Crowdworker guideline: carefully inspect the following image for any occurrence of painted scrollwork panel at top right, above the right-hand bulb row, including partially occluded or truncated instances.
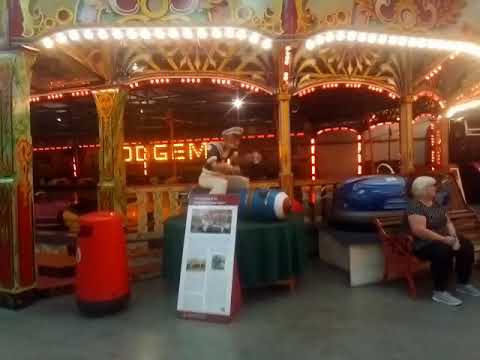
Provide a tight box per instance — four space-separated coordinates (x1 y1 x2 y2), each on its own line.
296 0 480 37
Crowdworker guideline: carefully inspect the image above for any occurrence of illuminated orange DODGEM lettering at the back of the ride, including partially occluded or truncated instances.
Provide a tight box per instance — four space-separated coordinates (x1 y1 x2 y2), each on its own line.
123 142 208 163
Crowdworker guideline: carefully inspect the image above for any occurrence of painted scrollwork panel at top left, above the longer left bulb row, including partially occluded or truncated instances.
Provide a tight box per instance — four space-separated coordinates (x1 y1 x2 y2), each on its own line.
12 0 282 38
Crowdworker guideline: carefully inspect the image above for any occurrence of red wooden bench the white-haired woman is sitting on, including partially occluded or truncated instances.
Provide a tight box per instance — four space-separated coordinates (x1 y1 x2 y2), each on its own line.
375 208 480 297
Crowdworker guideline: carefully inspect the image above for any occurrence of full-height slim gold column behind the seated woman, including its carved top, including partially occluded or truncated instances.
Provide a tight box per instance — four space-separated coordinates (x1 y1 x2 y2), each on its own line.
400 52 415 176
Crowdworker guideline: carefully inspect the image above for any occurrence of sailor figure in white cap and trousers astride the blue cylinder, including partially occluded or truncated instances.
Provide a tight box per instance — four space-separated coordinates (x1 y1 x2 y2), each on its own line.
198 127 249 195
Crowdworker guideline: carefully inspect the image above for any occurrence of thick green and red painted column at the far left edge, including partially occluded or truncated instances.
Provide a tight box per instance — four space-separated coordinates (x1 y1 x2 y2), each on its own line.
0 50 36 308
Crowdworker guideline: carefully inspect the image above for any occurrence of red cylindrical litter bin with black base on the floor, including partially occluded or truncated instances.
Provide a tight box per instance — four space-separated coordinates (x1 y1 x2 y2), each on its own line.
75 212 130 315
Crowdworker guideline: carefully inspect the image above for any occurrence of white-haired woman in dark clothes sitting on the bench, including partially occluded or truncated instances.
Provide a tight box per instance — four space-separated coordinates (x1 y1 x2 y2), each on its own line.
407 176 480 306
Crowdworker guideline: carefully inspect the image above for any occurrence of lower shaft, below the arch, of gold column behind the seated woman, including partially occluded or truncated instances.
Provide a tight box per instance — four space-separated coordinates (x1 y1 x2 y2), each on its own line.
400 95 415 175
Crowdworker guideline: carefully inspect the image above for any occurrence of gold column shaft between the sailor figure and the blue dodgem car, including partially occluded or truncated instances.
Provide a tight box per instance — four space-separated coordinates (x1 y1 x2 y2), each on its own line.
277 92 293 196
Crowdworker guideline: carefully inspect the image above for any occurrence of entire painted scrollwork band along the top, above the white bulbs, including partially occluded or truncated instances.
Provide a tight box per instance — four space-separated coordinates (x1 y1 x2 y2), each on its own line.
6 0 480 39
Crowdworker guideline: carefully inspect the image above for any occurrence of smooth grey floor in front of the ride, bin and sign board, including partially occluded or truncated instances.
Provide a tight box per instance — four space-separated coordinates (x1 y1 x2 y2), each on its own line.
0 263 480 360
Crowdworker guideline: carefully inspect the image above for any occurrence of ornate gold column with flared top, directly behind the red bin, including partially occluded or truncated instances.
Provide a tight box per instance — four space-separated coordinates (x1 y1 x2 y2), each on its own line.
94 88 128 215
